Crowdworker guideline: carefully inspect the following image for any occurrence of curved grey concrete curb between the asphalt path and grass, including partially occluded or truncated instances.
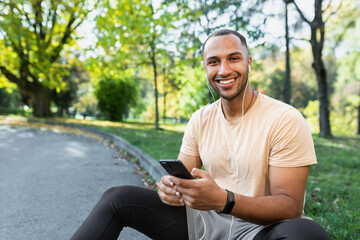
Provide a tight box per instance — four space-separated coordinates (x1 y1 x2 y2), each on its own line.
28 119 167 181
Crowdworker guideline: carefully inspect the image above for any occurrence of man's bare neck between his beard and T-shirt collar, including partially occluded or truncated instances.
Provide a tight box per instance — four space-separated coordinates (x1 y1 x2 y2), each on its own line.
221 86 257 122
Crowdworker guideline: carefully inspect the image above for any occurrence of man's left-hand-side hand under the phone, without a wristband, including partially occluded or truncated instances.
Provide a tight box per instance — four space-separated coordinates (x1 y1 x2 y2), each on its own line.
157 176 185 206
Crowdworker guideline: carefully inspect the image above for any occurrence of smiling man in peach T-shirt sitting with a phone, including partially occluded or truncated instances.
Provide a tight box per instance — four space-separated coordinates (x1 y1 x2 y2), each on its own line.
69 30 329 239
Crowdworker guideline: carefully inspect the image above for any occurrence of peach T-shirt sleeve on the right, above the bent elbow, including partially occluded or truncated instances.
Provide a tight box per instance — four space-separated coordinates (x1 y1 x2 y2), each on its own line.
269 108 317 167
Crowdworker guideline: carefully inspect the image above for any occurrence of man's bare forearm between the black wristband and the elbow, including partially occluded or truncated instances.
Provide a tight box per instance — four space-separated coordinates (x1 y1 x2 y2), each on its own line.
231 194 302 225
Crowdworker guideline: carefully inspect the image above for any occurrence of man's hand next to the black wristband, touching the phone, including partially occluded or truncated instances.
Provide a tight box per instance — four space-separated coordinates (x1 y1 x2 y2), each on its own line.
168 168 227 210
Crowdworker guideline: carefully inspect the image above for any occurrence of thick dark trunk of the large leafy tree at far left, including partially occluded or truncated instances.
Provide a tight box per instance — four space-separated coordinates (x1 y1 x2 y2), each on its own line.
31 84 52 117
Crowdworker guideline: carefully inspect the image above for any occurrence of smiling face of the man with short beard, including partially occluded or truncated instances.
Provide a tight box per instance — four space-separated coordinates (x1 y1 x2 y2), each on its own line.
203 35 251 100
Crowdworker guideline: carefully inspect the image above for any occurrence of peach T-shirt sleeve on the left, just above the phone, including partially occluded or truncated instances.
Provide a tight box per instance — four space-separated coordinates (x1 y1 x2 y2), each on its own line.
180 111 200 157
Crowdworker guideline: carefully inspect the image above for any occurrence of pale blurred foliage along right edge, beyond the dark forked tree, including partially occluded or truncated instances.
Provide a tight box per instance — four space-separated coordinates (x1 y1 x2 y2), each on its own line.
333 7 360 134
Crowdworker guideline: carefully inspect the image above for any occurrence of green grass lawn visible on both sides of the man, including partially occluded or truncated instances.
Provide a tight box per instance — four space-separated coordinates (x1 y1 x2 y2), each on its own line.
0 116 360 240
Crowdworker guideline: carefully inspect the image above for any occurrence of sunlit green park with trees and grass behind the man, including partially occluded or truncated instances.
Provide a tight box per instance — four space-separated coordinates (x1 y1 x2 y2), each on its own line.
0 0 360 239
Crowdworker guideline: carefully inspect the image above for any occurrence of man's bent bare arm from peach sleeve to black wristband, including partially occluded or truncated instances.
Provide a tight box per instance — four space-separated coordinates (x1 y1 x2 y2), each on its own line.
231 166 310 225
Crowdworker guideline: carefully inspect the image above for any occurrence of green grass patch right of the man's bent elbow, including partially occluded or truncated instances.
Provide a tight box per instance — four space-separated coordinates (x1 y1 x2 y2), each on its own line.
305 137 360 240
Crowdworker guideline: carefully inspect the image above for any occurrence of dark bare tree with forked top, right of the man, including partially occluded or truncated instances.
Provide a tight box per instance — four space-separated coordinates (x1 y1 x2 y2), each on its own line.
290 0 341 137
